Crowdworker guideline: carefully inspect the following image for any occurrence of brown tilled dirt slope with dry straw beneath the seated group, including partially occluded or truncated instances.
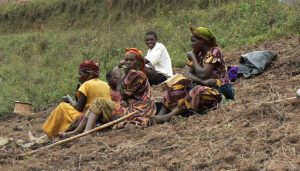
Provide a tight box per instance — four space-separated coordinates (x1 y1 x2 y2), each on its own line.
0 37 300 170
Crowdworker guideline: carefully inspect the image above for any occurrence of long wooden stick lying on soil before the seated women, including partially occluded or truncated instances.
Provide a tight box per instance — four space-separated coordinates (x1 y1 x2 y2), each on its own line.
21 111 138 156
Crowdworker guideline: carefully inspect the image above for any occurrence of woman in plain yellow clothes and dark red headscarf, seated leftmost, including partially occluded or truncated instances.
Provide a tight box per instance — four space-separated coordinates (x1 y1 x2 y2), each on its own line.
39 60 110 138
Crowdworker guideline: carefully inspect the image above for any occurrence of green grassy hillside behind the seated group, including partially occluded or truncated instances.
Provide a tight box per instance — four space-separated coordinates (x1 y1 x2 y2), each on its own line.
0 0 300 115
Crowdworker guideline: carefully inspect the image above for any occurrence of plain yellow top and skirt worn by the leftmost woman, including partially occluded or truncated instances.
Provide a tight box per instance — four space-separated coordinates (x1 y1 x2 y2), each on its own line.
43 78 111 138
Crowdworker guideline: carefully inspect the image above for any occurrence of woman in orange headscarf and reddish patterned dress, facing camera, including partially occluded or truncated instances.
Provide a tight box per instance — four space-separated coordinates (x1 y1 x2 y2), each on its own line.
62 48 156 136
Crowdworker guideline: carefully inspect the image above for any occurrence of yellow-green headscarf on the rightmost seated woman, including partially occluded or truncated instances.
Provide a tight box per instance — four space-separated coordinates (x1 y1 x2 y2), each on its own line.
190 26 218 47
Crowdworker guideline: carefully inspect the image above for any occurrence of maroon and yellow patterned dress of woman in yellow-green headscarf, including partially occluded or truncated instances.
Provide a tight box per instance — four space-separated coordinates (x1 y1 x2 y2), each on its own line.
164 47 229 112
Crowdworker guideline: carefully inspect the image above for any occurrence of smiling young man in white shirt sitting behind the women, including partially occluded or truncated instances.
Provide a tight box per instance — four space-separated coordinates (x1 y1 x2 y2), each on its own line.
145 31 173 85
